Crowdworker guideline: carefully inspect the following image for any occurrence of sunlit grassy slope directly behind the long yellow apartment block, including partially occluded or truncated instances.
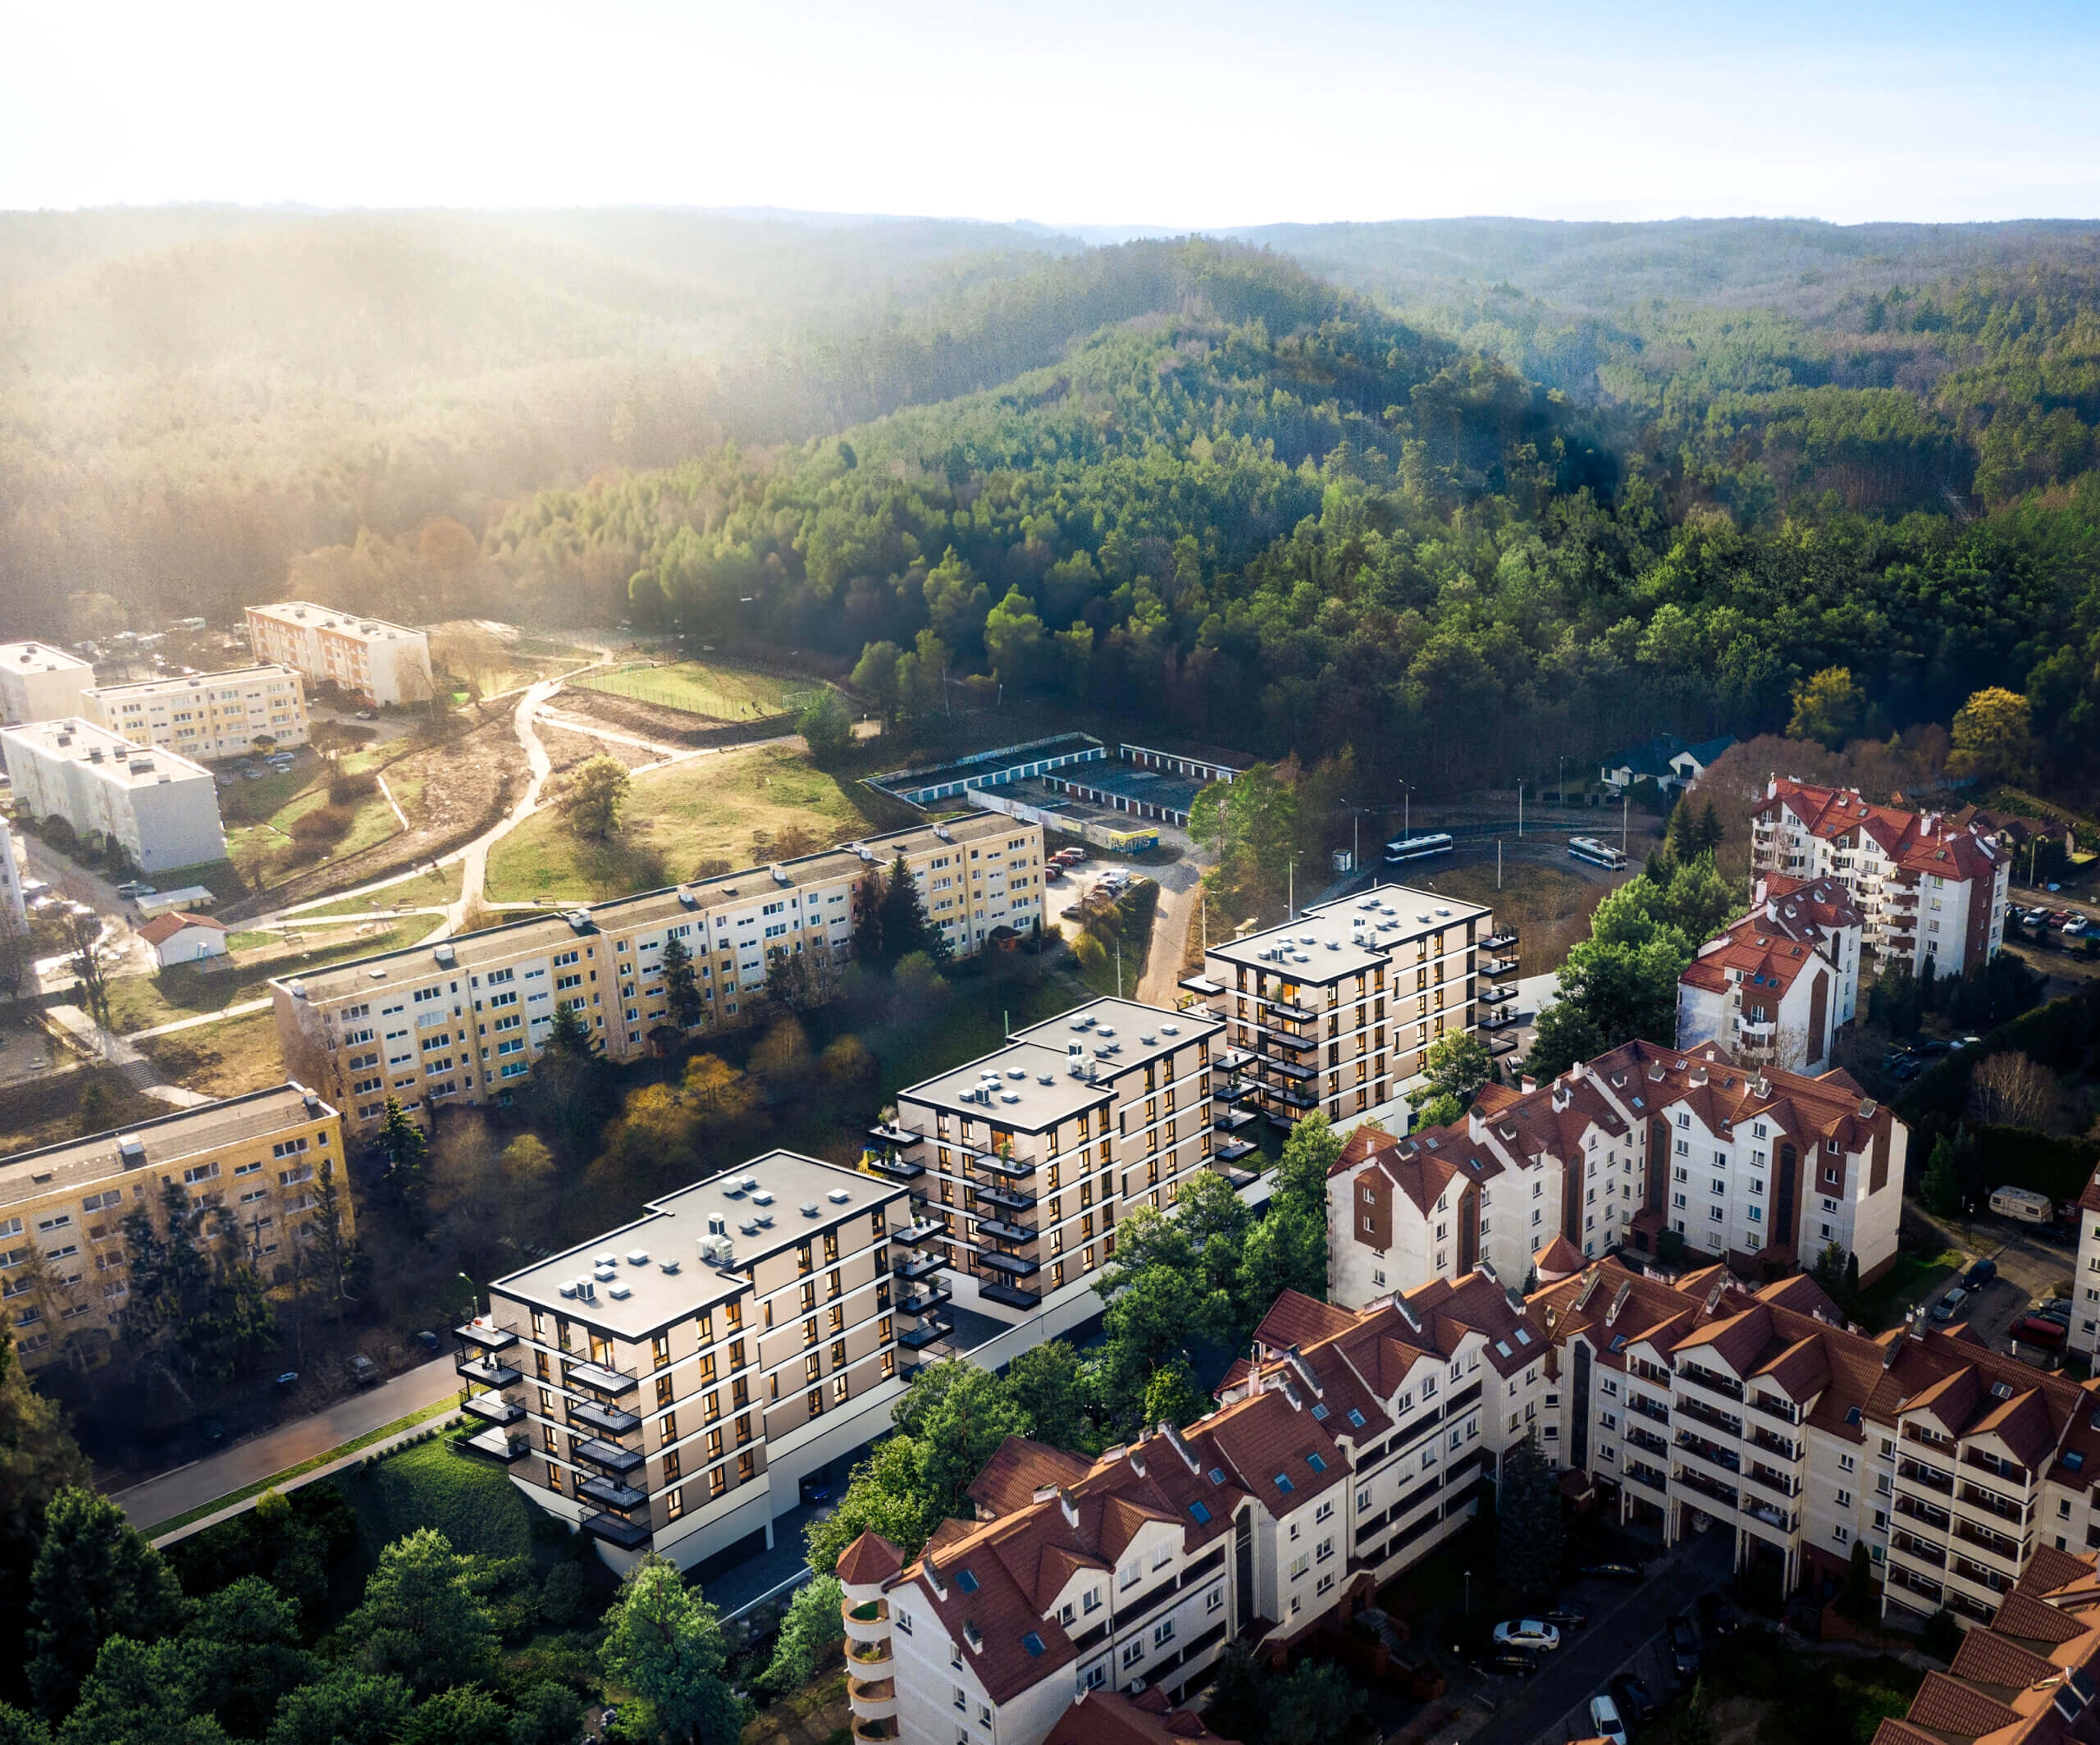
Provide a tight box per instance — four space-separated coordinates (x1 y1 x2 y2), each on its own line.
487 746 870 903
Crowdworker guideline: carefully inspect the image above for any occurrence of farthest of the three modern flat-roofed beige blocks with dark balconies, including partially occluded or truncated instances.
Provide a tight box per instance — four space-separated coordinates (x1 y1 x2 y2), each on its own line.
1182 884 1516 1127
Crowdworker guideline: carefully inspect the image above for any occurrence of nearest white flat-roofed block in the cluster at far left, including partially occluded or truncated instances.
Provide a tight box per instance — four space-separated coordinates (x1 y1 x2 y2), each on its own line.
0 716 226 874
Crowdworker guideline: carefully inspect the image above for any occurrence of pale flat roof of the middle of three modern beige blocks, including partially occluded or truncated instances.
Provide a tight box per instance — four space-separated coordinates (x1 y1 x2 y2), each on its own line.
897 998 1224 1132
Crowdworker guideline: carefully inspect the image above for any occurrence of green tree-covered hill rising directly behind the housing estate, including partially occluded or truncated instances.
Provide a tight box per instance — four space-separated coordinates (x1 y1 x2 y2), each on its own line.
489 244 2100 788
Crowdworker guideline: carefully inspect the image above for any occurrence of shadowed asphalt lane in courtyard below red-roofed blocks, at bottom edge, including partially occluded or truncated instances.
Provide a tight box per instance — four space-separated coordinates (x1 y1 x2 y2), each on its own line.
1463 1527 1735 1745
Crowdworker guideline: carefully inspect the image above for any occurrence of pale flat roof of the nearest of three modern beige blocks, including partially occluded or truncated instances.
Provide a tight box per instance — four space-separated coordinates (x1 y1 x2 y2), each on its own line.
489 1151 905 1340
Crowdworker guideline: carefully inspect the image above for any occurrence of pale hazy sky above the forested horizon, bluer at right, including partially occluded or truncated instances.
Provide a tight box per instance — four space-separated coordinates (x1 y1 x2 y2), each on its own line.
0 0 2100 226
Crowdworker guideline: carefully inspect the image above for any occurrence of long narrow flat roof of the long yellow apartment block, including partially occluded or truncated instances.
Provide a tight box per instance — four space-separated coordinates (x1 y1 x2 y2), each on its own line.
281 810 1034 999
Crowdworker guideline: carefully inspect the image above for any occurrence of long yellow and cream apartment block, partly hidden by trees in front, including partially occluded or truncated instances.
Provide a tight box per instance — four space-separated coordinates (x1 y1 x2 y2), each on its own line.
271 813 1043 1132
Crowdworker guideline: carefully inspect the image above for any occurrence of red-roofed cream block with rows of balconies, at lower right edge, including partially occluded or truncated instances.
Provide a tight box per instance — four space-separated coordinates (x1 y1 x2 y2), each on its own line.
1531 1258 2100 1624
